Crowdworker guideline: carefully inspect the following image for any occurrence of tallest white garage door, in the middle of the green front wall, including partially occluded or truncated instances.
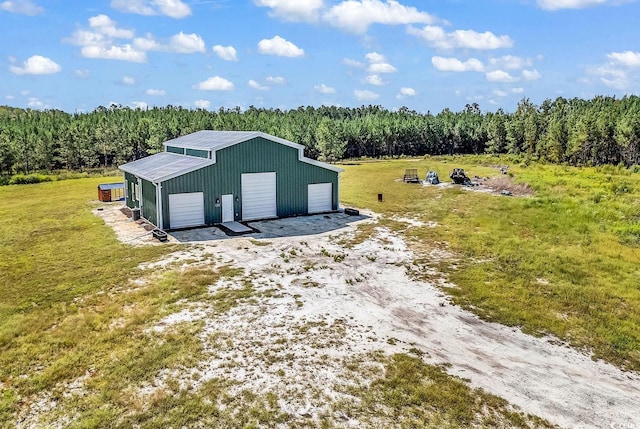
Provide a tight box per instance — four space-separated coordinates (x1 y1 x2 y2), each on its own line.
242 172 278 220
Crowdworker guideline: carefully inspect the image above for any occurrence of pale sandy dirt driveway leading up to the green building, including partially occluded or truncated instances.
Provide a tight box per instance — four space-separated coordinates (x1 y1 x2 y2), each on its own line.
97 206 640 428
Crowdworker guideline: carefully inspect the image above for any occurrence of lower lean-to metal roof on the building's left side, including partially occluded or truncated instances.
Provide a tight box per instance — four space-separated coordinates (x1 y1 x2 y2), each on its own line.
120 152 215 183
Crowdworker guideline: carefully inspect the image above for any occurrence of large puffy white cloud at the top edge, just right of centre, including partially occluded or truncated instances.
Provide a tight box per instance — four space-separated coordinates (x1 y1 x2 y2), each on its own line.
323 0 437 34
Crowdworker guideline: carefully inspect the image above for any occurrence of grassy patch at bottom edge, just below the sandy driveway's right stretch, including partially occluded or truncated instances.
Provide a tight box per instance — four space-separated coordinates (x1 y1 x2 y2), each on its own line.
337 354 552 428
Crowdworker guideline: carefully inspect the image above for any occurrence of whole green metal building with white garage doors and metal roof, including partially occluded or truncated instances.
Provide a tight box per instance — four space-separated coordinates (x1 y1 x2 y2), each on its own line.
120 131 343 229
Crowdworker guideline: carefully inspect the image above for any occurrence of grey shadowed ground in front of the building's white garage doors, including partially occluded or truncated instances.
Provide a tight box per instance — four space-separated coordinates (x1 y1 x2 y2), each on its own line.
170 212 371 243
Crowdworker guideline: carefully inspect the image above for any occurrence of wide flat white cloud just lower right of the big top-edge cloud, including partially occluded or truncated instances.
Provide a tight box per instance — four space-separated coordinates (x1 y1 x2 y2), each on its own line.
407 25 513 50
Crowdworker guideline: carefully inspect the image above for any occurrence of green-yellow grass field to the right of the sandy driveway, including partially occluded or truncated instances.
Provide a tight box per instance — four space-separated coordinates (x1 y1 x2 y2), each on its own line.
341 157 640 371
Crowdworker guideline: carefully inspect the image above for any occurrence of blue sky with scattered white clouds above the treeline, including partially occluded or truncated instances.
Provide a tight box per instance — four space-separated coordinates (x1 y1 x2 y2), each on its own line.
0 0 640 113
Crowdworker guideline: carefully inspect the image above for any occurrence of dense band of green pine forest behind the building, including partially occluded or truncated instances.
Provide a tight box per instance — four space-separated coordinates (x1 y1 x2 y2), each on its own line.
0 96 640 177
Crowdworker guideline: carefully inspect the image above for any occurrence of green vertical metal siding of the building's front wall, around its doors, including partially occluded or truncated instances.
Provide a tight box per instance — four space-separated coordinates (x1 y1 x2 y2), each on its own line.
162 138 338 228
